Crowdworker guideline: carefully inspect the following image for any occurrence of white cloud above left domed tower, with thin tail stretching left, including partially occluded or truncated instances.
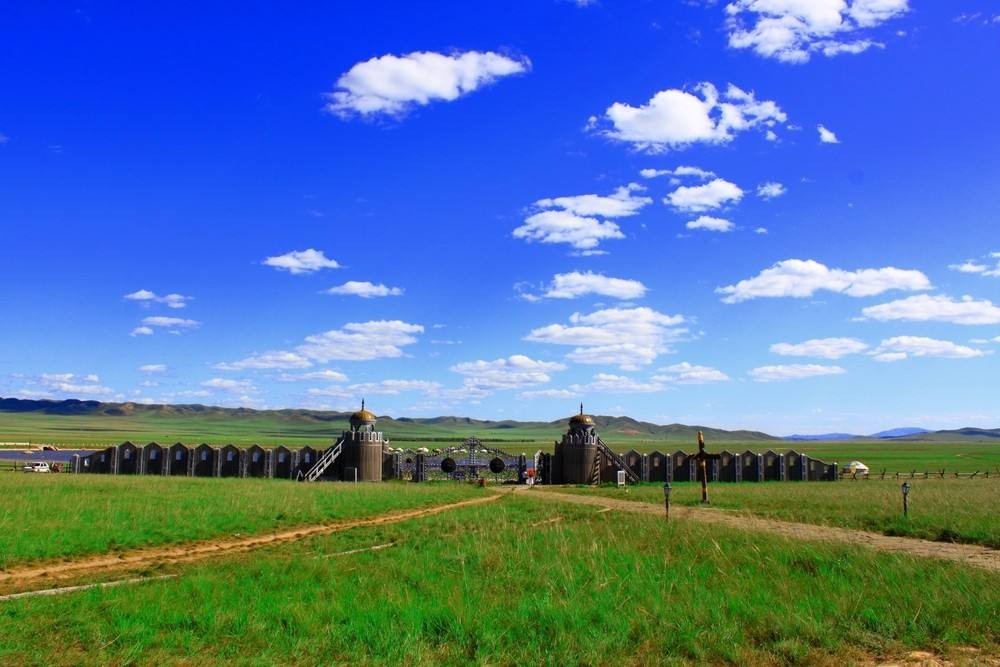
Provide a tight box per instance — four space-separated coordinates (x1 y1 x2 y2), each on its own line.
215 320 424 370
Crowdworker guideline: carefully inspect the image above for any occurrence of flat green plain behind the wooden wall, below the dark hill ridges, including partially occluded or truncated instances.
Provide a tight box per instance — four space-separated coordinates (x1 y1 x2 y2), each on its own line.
0 404 1000 475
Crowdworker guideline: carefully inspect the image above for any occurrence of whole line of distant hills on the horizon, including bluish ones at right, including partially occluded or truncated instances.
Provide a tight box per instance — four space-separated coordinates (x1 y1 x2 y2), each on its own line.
0 398 1000 445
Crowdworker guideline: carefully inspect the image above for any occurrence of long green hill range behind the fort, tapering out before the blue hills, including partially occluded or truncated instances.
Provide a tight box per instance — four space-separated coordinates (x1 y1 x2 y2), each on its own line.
0 398 778 443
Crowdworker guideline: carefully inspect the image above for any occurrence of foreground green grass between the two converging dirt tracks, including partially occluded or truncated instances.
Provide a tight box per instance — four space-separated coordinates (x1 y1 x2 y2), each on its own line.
0 497 1000 665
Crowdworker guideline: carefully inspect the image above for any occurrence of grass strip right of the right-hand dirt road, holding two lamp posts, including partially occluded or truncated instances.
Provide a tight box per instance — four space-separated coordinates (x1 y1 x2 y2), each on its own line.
540 478 1000 549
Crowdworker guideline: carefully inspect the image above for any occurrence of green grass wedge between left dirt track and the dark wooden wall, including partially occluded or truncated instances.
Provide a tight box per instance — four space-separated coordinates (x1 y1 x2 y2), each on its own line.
0 472 481 569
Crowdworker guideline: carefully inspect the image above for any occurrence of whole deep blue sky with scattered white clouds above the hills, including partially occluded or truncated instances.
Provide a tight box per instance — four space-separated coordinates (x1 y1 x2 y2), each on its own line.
0 0 1000 434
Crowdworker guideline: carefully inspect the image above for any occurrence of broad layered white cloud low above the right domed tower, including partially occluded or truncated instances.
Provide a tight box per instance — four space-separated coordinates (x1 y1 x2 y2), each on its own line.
525 307 687 370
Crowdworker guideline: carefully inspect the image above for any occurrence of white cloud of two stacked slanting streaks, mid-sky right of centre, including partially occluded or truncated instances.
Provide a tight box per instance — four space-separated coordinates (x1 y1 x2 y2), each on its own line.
514 183 653 254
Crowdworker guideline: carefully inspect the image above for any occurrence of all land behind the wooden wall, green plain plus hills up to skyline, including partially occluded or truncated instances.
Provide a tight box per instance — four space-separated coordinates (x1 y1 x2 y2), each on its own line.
0 399 1000 474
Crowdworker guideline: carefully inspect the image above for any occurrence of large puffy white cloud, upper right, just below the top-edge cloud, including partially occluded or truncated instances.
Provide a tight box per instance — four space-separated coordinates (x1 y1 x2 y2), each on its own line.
590 82 787 153
